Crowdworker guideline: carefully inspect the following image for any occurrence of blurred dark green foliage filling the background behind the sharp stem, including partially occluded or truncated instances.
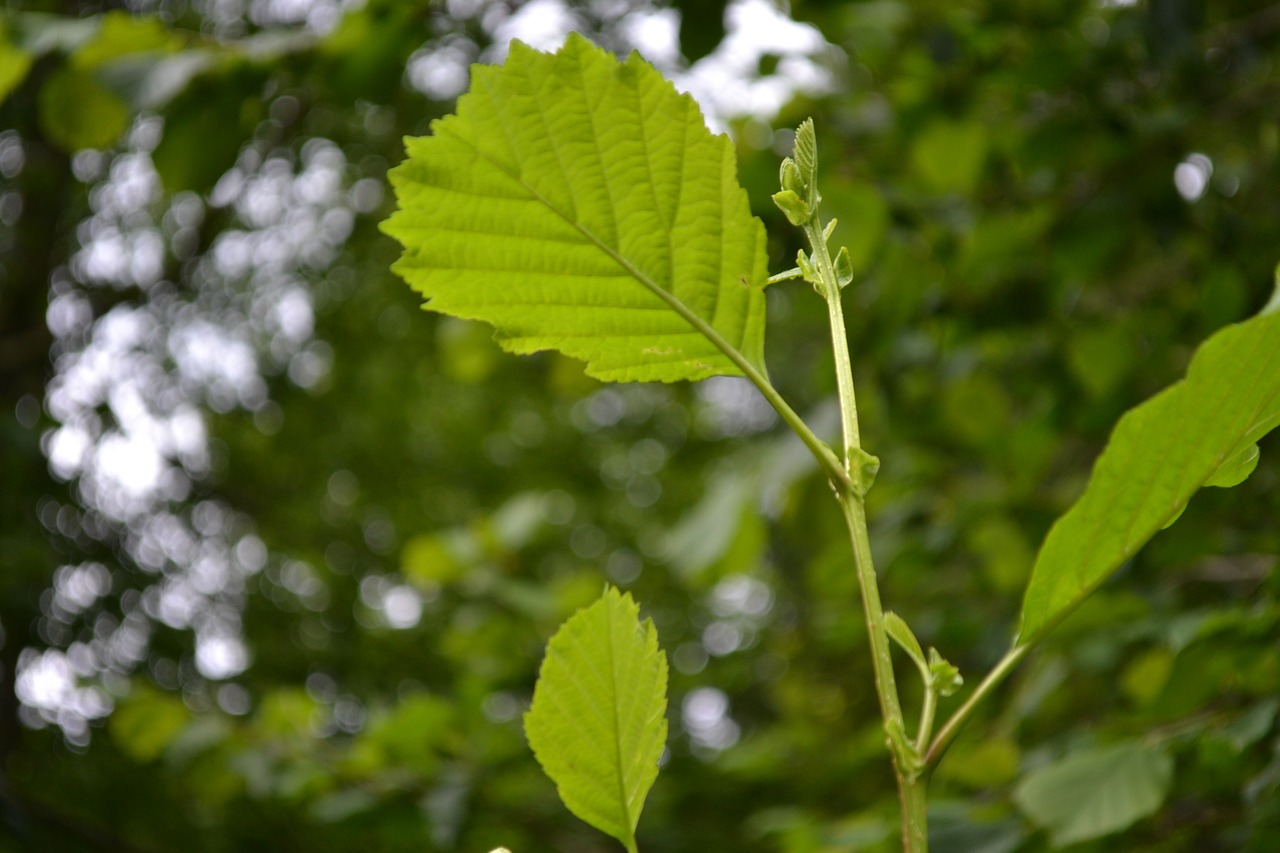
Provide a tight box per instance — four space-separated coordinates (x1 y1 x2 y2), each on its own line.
0 0 1280 853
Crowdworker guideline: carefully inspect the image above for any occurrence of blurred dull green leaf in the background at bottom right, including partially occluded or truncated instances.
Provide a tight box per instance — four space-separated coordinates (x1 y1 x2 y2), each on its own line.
1014 742 1174 847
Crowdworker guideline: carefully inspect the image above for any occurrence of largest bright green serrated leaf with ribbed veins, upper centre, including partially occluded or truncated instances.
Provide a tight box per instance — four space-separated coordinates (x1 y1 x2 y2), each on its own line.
383 36 768 382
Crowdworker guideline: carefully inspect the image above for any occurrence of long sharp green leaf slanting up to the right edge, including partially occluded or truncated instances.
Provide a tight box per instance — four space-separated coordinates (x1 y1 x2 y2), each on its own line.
1019 306 1280 643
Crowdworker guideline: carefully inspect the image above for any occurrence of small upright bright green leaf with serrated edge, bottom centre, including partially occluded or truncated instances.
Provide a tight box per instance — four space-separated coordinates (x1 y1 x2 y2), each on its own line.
525 587 667 850
